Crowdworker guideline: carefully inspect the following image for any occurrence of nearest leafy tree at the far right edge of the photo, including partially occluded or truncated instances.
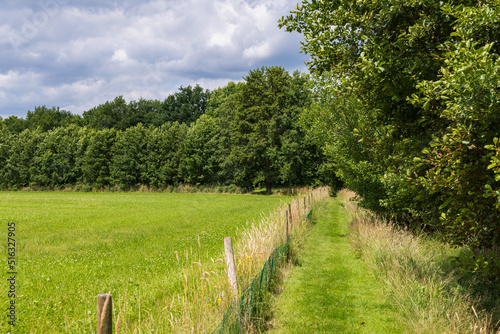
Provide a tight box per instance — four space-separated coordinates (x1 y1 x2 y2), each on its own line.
412 6 500 246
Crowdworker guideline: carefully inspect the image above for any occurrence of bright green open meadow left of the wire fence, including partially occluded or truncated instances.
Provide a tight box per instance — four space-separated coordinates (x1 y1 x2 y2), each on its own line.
0 192 288 334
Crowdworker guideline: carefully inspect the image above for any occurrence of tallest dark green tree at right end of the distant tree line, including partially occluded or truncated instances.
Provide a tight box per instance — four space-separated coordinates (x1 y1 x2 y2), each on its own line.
213 67 319 193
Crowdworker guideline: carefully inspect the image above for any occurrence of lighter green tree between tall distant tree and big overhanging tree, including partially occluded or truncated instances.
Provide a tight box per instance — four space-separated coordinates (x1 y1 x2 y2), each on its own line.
301 74 390 212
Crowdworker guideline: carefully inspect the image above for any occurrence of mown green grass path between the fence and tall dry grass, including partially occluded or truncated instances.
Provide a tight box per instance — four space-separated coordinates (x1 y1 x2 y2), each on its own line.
268 198 404 333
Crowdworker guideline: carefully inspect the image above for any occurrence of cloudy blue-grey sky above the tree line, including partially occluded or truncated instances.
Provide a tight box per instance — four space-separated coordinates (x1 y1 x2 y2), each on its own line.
0 0 308 118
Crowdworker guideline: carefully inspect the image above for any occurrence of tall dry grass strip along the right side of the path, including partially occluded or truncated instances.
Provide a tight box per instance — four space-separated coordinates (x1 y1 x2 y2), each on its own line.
339 190 500 334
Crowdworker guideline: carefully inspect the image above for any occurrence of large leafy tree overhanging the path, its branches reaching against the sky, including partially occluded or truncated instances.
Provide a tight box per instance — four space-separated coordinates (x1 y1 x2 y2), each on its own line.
280 1 458 215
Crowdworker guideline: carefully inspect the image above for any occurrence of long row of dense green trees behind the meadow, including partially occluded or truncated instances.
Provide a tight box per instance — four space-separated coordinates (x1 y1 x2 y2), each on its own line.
0 67 335 192
